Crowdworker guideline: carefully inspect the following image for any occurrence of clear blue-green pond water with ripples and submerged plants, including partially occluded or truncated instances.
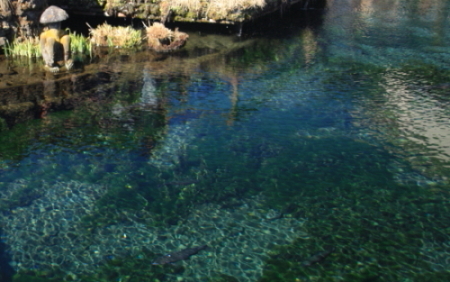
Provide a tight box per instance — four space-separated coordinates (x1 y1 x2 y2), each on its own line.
0 0 450 282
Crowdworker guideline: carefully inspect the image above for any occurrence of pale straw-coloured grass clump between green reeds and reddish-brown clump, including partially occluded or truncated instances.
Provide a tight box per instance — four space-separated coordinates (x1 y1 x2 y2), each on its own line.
90 23 142 48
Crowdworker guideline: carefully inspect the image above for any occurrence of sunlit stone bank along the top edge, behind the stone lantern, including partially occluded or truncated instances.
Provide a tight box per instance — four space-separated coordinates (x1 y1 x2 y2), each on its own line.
0 0 326 46
